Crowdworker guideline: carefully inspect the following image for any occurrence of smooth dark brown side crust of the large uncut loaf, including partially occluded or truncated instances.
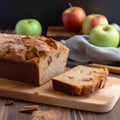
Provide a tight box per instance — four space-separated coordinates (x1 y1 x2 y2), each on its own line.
0 60 39 85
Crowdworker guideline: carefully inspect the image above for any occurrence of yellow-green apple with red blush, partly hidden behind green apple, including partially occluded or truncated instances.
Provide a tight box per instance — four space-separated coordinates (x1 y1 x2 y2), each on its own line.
82 14 108 35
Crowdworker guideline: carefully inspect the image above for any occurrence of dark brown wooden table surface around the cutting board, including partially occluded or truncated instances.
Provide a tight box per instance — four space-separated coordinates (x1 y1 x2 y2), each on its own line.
0 30 120 120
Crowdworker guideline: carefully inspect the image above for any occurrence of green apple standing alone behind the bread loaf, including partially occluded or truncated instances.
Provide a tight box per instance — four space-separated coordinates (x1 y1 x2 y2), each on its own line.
15 19 42 36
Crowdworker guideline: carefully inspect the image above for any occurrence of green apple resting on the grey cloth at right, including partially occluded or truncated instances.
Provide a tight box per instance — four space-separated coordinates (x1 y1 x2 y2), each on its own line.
89 25 119 48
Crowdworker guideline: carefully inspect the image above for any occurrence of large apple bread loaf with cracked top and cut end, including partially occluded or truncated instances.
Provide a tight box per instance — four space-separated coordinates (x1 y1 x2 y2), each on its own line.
0 34 69 85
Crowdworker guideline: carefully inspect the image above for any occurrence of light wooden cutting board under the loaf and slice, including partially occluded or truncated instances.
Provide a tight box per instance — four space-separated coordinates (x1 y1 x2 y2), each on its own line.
0 77 120 112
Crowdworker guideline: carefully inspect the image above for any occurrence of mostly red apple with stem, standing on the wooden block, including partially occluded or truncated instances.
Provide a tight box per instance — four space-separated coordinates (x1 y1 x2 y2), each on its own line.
62 3 86 32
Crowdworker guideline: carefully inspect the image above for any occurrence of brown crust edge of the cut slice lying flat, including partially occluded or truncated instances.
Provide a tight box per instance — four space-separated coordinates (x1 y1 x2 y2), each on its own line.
52 67 109 96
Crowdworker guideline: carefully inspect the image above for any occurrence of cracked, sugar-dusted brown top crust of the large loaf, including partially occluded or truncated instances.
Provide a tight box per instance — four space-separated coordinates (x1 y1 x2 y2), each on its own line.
0 34 58 62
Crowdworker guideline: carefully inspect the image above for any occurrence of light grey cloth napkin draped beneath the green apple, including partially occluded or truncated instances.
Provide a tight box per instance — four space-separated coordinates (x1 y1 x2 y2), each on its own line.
61 24 120 64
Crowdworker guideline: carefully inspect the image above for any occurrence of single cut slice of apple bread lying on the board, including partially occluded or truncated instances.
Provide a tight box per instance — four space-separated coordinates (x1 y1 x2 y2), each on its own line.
52 65 109 96
